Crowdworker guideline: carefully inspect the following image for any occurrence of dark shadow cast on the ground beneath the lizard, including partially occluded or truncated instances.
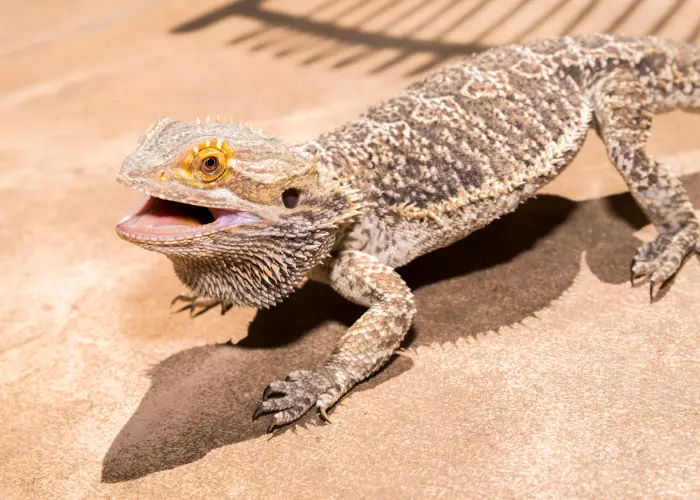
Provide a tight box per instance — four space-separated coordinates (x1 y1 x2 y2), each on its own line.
102 175 700 482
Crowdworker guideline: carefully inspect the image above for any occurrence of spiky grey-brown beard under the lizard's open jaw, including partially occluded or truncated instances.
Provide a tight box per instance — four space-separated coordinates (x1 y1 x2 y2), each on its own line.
151 227 335 308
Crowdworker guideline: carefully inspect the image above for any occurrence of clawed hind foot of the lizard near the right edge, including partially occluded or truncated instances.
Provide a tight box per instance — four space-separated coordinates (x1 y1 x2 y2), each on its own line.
630 225 698 300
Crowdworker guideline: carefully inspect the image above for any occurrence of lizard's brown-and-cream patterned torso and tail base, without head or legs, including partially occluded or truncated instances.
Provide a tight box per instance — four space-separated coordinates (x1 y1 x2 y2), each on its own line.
308 36 700 266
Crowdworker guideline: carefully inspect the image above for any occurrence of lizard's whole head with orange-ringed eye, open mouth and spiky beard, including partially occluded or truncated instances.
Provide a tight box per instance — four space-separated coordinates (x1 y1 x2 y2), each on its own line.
116 118 360 307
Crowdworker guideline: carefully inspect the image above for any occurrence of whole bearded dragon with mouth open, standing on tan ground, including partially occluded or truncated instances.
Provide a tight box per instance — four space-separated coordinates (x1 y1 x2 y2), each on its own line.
116 35 700 432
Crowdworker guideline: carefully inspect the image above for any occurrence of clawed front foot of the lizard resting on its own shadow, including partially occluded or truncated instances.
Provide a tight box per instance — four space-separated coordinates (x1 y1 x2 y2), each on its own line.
253 370 342 432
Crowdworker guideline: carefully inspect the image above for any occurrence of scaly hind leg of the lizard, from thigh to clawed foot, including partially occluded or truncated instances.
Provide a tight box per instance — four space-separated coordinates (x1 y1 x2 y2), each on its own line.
593 73 699 299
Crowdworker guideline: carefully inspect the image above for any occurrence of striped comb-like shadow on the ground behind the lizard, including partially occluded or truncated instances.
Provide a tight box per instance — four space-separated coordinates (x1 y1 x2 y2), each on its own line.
171 0 700 76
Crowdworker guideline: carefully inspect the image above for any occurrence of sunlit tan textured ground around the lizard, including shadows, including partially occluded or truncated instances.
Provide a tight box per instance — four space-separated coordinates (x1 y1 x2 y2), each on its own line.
0 0 700 499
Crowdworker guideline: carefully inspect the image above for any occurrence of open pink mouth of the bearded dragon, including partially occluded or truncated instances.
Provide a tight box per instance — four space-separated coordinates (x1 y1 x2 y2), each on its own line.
117 196 260 241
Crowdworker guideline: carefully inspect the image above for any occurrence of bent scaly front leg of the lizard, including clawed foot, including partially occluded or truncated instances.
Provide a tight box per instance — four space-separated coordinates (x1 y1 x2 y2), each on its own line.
253 251 416 432
